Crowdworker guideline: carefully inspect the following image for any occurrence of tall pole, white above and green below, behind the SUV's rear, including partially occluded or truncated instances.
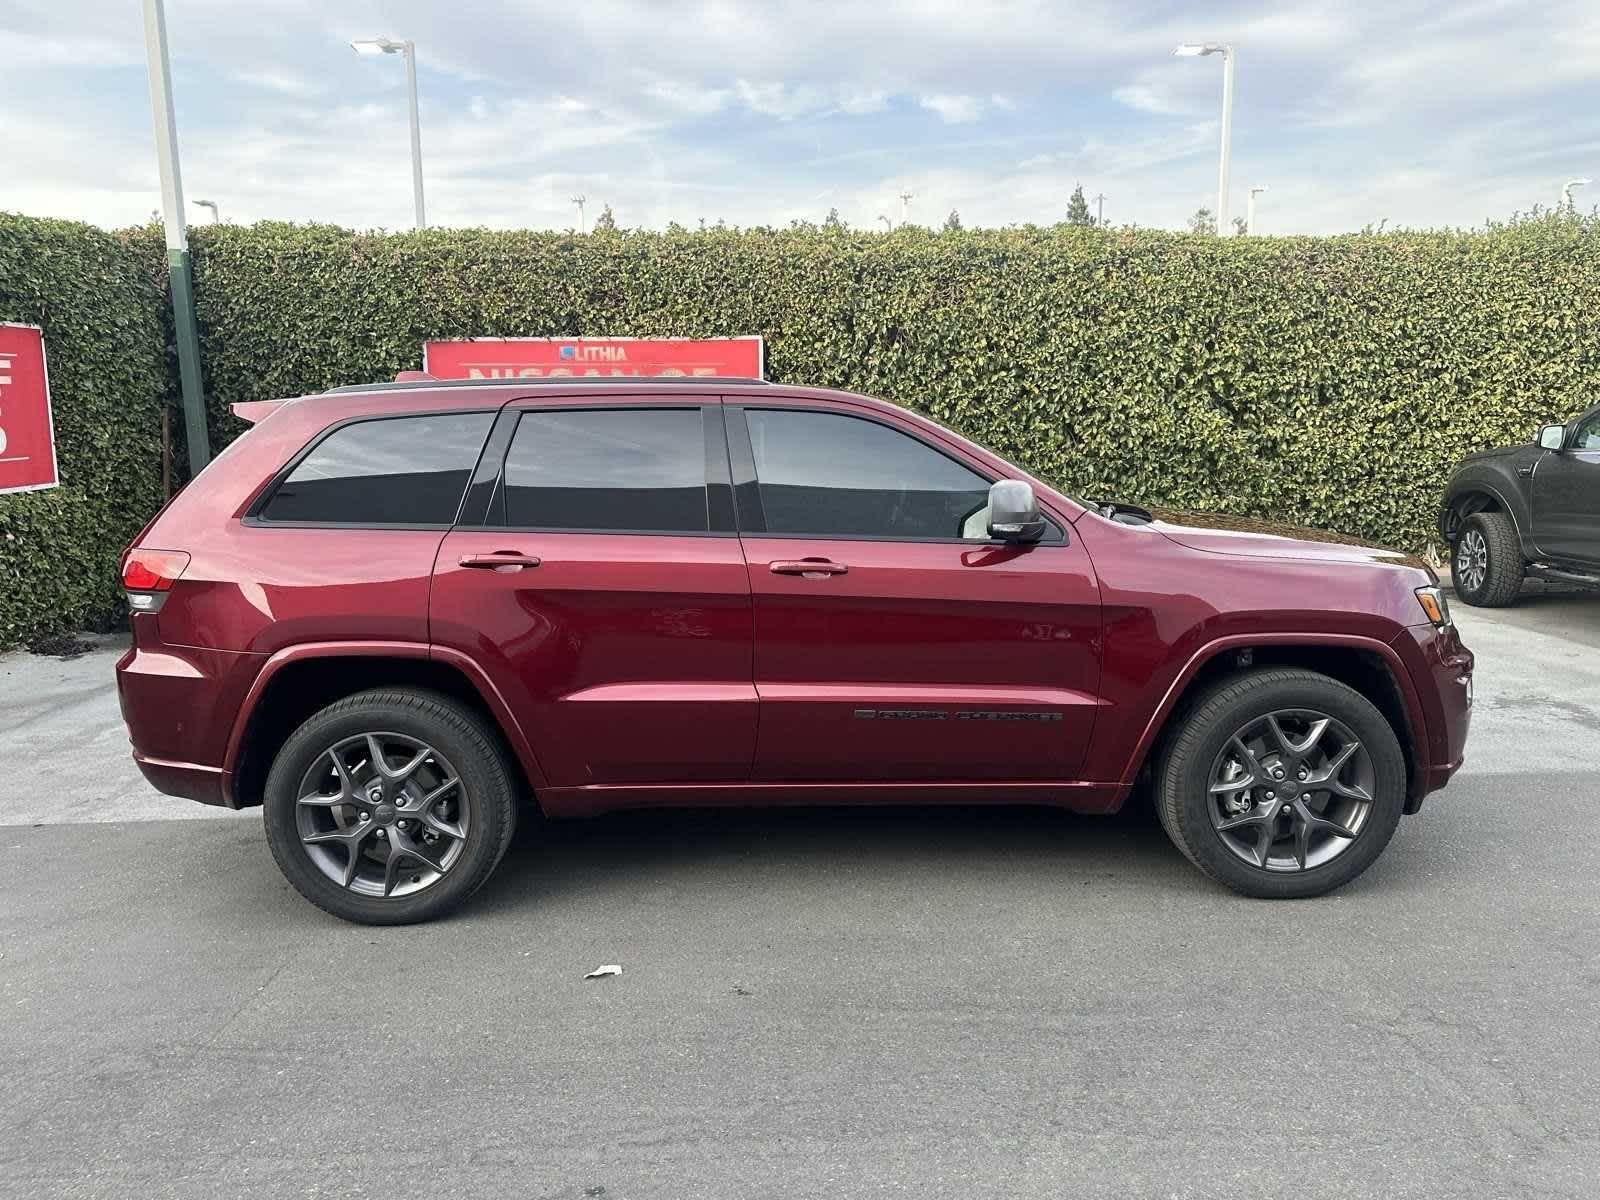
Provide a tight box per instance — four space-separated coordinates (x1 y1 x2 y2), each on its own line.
144 0 211 475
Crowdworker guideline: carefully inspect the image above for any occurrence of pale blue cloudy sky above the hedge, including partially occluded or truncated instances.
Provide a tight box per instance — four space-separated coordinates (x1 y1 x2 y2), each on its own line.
0 0 1600 234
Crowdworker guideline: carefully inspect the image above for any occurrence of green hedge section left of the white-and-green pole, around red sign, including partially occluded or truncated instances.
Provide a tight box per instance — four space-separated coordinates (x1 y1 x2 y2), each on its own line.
0 213 171 646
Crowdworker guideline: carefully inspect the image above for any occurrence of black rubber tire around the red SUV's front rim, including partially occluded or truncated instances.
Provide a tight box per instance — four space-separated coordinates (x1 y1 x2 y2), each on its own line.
1155 667 1406 899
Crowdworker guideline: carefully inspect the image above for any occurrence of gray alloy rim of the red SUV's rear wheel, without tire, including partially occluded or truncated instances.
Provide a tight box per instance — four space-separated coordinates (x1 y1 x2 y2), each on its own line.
296 733 472 896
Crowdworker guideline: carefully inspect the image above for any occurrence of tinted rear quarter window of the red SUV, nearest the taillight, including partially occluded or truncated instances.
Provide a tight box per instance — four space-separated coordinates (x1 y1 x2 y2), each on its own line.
261 413 494 525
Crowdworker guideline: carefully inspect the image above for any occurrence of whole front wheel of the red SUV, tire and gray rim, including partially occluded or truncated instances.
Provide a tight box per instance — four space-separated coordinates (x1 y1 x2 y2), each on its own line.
1155 669 1406 899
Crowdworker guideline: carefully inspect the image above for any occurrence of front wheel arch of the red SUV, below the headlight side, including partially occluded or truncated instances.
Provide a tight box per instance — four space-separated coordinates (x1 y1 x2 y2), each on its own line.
1122 634 1427 813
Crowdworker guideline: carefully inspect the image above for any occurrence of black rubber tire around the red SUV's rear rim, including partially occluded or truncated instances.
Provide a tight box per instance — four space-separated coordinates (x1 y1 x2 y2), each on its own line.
264 688 517 925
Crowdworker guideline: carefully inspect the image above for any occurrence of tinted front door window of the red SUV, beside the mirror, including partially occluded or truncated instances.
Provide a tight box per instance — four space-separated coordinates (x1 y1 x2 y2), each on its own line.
746 408 989 539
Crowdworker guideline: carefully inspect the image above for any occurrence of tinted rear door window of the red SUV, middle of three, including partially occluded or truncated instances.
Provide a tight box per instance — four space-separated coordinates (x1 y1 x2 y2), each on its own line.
502 408 710 533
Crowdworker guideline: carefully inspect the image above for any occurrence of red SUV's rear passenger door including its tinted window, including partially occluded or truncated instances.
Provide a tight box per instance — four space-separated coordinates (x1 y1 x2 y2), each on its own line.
430 397 757 786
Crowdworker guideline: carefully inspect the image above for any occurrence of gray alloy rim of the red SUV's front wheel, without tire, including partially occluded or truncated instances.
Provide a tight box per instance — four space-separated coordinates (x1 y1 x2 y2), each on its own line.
1206 709 1373 870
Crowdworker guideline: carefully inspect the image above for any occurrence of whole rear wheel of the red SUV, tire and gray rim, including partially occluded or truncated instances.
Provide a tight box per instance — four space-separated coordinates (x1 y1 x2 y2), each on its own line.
264 688 515 925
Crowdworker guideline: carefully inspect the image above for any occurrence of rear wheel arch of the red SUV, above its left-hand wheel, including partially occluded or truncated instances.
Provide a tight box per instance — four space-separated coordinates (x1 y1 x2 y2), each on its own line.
224 642 544 808
